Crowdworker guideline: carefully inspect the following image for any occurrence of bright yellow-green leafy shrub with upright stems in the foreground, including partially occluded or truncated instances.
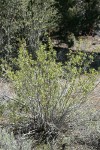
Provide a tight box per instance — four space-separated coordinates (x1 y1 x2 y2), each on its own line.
2 41 95 124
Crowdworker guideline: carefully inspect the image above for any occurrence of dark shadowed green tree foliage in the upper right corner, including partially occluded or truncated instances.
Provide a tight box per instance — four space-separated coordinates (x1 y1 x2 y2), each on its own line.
56 0 100 40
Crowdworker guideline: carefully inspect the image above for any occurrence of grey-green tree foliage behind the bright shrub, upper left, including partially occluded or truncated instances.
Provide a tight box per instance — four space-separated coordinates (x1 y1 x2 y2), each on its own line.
0 0 57 63
